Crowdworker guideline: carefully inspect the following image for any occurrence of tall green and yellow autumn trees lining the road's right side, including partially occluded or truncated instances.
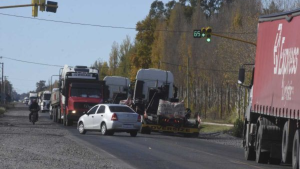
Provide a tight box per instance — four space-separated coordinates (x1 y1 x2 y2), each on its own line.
93 0 300 119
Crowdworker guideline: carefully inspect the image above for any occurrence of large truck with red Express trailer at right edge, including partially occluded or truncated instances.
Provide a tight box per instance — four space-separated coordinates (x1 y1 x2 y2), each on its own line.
238 9 300 169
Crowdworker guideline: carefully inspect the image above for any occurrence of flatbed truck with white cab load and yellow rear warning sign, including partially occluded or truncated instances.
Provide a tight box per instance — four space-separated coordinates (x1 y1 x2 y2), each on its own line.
133 69 199 137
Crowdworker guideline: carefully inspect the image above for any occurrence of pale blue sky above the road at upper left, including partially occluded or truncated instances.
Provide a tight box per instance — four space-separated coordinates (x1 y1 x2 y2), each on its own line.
0 0 168 93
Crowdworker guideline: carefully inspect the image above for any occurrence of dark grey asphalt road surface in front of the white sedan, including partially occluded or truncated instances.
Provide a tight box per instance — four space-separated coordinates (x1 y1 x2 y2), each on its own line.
13 103 291 169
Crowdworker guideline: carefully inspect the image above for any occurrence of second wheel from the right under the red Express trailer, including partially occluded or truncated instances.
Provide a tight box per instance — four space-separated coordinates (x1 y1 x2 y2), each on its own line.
281 121 295 163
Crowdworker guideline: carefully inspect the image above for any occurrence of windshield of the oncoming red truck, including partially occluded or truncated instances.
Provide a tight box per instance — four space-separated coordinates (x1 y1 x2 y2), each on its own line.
71 88 101 98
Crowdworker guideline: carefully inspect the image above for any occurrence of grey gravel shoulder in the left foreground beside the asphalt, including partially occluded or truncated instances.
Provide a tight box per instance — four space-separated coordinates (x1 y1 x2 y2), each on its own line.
0 104 132 169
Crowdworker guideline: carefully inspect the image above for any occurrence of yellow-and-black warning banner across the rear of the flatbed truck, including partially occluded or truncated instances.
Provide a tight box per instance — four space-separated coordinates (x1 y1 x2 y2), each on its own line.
142 124 200 134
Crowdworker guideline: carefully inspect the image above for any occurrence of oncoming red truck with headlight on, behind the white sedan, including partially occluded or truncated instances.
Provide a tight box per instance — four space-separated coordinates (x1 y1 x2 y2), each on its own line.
51 65 105 126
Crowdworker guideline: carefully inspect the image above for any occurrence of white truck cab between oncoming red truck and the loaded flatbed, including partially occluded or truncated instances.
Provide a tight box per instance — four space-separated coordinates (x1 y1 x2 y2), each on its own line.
103 76 130 104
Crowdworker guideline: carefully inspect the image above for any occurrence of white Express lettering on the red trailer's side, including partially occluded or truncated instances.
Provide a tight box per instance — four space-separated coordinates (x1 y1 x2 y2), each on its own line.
273 24 299 100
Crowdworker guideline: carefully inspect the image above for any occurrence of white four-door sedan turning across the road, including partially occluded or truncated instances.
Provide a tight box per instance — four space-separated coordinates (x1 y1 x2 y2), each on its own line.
77 104 142 137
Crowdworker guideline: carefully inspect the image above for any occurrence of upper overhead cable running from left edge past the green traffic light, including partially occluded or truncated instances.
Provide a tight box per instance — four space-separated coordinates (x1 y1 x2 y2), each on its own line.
0 13 256 34
